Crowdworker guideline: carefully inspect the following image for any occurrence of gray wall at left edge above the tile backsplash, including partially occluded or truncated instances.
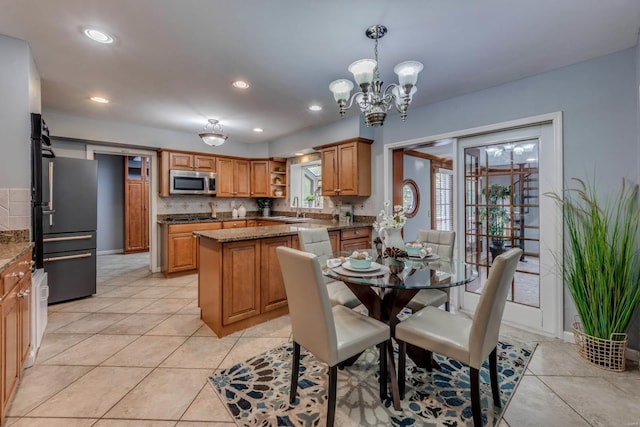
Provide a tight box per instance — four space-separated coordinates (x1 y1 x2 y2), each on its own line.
0 35 40 188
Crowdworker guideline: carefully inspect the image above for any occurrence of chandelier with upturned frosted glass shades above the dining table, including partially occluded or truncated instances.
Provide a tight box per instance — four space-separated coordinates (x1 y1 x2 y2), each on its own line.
329 25 423 127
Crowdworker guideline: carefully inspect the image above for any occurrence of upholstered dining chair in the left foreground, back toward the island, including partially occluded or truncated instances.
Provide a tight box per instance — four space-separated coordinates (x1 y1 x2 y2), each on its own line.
276 246 391 426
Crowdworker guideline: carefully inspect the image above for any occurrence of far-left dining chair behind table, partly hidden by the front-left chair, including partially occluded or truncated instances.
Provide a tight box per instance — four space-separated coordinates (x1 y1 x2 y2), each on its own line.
298 228 360 308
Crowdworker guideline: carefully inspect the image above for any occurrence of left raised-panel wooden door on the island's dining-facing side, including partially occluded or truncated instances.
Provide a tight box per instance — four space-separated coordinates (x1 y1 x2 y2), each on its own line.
222 240 261 325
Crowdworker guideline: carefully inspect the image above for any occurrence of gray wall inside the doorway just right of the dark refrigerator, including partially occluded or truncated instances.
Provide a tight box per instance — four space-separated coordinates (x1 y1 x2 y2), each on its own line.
95 154 124 252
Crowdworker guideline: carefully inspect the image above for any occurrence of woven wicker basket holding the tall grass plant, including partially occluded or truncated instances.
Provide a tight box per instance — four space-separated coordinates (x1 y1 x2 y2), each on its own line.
573 321 627 372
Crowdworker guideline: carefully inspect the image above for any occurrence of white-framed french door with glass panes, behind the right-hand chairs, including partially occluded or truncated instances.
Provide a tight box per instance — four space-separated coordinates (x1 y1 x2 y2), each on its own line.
456 124 563 336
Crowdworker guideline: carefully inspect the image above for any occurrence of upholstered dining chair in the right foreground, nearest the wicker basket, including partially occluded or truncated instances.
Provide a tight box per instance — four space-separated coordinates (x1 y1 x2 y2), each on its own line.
395 248 522 427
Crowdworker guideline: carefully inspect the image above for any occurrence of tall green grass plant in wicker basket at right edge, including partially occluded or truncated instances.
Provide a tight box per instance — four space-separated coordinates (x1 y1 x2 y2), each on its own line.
549 178 640 371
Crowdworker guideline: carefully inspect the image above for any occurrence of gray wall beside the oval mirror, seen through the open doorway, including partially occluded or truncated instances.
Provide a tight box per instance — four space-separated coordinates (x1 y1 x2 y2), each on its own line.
403 155 431 241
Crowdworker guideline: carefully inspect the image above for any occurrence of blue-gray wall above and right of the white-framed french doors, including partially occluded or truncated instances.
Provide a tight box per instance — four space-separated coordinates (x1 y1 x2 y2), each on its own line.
374 48 640 349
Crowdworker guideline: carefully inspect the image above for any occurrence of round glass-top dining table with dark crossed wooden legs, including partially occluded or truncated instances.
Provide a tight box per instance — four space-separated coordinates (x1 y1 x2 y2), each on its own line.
322 254 478 410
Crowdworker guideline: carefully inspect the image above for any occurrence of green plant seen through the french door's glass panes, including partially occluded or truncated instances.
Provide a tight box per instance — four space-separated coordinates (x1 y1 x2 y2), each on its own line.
480 184 511 260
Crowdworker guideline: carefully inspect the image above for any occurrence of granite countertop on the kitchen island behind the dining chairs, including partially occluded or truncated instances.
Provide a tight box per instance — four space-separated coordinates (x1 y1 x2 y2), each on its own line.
198 220 371 243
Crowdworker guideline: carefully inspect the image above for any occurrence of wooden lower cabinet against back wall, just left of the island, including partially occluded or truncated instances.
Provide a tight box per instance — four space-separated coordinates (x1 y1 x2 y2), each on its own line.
161 222 222 276
